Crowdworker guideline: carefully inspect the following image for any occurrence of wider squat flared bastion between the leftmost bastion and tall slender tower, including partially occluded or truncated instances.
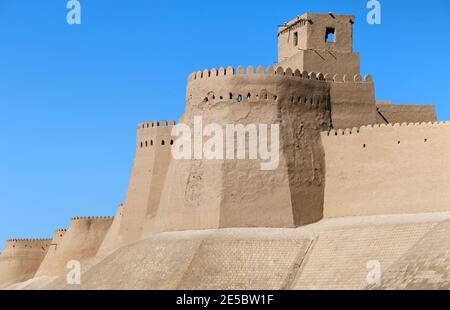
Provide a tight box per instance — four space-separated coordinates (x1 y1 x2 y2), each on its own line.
35 217 113 277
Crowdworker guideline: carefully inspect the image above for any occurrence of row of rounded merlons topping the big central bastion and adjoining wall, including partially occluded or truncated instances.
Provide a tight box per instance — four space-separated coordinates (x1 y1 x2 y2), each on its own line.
188 65 373 83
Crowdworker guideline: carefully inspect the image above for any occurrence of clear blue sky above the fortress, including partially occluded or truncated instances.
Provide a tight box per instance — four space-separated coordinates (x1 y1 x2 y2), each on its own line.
0 0 450 246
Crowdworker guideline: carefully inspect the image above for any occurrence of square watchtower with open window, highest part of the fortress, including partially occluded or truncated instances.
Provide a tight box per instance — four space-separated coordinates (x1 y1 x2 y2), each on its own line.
278 13 360 76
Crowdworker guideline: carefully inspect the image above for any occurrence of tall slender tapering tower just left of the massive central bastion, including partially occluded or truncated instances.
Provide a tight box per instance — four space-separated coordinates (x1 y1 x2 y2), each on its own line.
116 121 175 249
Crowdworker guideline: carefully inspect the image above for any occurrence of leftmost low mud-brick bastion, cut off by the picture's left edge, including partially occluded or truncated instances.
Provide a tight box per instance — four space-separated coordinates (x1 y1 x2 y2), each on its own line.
0 239 51 288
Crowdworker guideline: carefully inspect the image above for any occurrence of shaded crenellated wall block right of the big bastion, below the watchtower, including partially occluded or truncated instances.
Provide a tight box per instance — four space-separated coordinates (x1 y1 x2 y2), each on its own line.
330 75 378 129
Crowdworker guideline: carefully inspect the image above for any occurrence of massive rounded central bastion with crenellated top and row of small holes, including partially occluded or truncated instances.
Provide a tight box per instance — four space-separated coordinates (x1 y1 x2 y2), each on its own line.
151 67 331 231
